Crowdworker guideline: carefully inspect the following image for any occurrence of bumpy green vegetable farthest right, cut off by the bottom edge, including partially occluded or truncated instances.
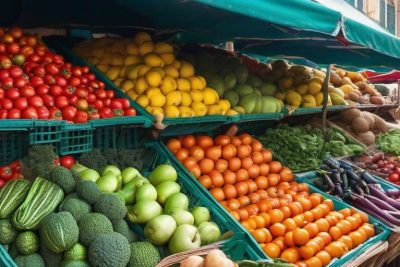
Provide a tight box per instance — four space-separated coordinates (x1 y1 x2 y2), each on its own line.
127 241 161 267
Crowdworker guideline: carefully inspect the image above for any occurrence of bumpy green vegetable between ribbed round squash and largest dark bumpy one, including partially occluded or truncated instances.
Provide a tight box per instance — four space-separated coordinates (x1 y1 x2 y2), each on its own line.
79 213 113 246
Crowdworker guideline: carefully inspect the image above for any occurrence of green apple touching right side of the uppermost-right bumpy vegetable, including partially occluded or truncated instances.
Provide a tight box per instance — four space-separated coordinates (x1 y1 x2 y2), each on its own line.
127 200 162 223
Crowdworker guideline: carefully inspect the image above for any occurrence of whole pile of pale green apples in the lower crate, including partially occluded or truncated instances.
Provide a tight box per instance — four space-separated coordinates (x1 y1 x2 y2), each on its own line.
73 164 221 253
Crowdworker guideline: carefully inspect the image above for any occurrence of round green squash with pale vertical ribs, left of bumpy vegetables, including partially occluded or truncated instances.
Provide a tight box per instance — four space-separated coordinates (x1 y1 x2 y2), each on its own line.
40 211 79 253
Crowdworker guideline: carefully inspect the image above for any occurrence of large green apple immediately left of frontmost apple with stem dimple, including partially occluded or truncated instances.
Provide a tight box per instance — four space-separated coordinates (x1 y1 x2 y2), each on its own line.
144 214 176 246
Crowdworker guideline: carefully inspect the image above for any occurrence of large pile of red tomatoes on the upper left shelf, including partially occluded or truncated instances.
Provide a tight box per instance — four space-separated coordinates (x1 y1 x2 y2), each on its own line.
0 28 136 123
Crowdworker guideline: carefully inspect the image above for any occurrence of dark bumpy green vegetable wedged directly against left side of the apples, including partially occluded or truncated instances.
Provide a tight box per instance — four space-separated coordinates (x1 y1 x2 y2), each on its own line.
94 193 127 220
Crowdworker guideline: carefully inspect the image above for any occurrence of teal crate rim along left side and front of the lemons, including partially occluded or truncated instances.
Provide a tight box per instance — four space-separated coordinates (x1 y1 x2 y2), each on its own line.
44 36 234 136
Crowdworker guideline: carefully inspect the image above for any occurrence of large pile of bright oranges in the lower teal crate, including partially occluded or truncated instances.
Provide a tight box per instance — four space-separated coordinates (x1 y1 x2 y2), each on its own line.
167 133 375 267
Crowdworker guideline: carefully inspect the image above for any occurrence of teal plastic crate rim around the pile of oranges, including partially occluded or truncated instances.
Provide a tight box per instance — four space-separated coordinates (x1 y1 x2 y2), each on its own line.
157 143 390 267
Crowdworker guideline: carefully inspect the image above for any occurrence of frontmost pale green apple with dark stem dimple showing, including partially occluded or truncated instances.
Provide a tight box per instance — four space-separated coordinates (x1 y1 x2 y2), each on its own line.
168 224 201 254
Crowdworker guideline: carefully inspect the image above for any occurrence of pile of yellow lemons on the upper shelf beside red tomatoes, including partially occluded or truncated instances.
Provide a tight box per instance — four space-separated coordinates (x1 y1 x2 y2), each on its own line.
74 32 237 118
